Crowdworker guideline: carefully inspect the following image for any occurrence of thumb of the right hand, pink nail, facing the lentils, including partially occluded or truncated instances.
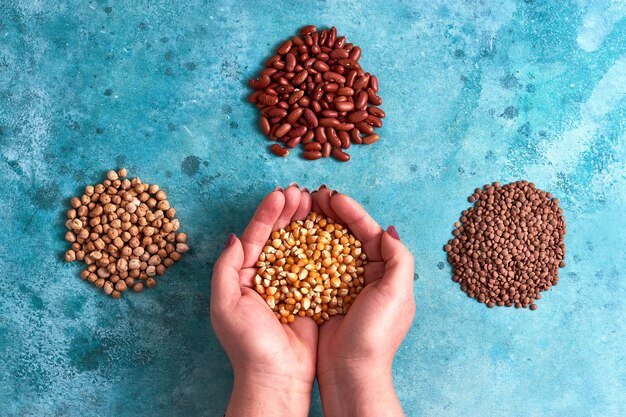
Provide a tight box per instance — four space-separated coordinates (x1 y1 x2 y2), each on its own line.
380 232 413 294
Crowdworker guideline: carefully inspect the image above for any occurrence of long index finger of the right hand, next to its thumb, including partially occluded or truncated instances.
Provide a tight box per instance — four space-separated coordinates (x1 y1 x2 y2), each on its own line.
330 194 383 261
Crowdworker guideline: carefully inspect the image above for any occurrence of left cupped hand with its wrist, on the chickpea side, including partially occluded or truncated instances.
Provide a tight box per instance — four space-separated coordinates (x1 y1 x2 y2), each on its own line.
211 185 318 417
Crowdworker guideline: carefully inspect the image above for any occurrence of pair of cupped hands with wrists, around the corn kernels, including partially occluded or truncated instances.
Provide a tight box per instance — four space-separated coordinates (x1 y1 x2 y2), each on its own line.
211 184 415 417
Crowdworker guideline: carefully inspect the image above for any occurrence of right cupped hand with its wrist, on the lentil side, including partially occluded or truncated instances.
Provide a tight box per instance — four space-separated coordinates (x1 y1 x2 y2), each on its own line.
312 188 415 417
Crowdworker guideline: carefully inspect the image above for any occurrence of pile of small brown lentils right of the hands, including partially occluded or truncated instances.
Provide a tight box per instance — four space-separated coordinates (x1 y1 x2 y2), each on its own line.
444 181 566 310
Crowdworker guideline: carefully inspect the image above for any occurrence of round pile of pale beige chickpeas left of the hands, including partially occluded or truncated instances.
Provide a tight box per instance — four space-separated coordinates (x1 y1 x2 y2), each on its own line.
65 168 189 298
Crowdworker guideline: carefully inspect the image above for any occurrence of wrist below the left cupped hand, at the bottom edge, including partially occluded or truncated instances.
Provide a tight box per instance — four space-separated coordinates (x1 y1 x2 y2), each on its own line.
226 370 313 417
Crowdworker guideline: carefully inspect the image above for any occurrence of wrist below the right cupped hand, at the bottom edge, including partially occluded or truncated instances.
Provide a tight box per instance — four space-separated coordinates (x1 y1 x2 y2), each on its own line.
318 363 404 417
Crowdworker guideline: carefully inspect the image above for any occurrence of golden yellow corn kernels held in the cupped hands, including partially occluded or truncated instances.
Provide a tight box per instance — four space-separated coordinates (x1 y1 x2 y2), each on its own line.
254 212 367 325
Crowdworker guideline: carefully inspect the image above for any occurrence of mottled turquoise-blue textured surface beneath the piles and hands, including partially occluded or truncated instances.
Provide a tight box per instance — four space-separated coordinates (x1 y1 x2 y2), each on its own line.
0 0 626 417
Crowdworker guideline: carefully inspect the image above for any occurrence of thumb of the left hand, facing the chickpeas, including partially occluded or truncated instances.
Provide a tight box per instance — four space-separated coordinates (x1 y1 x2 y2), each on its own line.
211 233 244 307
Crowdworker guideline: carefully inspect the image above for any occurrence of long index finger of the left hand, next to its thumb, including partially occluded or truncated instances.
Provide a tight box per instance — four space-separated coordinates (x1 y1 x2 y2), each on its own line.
241 190 285 268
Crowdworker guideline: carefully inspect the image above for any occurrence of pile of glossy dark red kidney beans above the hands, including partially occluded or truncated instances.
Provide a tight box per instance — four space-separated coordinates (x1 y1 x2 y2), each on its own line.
249 25 385 162
